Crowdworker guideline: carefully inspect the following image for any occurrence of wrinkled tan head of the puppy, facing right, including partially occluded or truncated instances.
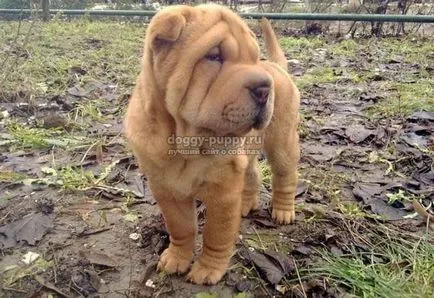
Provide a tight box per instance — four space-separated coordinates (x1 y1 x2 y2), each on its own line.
148 6 274 135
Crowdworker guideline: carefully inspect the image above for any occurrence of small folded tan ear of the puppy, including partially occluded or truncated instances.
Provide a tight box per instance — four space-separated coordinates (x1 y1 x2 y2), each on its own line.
148 11 186 50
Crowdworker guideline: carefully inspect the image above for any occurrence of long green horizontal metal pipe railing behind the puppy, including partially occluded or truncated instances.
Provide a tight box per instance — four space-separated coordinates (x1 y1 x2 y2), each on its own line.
0 9 434 23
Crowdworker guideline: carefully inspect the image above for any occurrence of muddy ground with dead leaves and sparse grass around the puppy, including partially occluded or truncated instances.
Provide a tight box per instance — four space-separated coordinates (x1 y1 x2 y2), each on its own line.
0 21 434 297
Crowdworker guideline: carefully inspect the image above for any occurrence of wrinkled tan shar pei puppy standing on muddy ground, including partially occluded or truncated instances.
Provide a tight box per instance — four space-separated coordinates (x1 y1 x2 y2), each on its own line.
124 5 299 284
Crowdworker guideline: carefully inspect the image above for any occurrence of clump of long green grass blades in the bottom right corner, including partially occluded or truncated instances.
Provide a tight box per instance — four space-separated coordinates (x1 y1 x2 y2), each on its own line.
305 225 434 298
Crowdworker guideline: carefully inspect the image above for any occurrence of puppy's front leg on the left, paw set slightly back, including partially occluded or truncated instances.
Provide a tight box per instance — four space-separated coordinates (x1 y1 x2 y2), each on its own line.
150 181 197 274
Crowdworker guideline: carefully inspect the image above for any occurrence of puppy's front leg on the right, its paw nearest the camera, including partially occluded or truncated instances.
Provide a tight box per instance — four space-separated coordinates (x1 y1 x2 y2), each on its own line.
188 175 243 284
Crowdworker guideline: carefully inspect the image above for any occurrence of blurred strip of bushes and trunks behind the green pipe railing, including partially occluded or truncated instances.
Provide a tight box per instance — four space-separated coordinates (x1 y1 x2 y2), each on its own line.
0 0 434 37
